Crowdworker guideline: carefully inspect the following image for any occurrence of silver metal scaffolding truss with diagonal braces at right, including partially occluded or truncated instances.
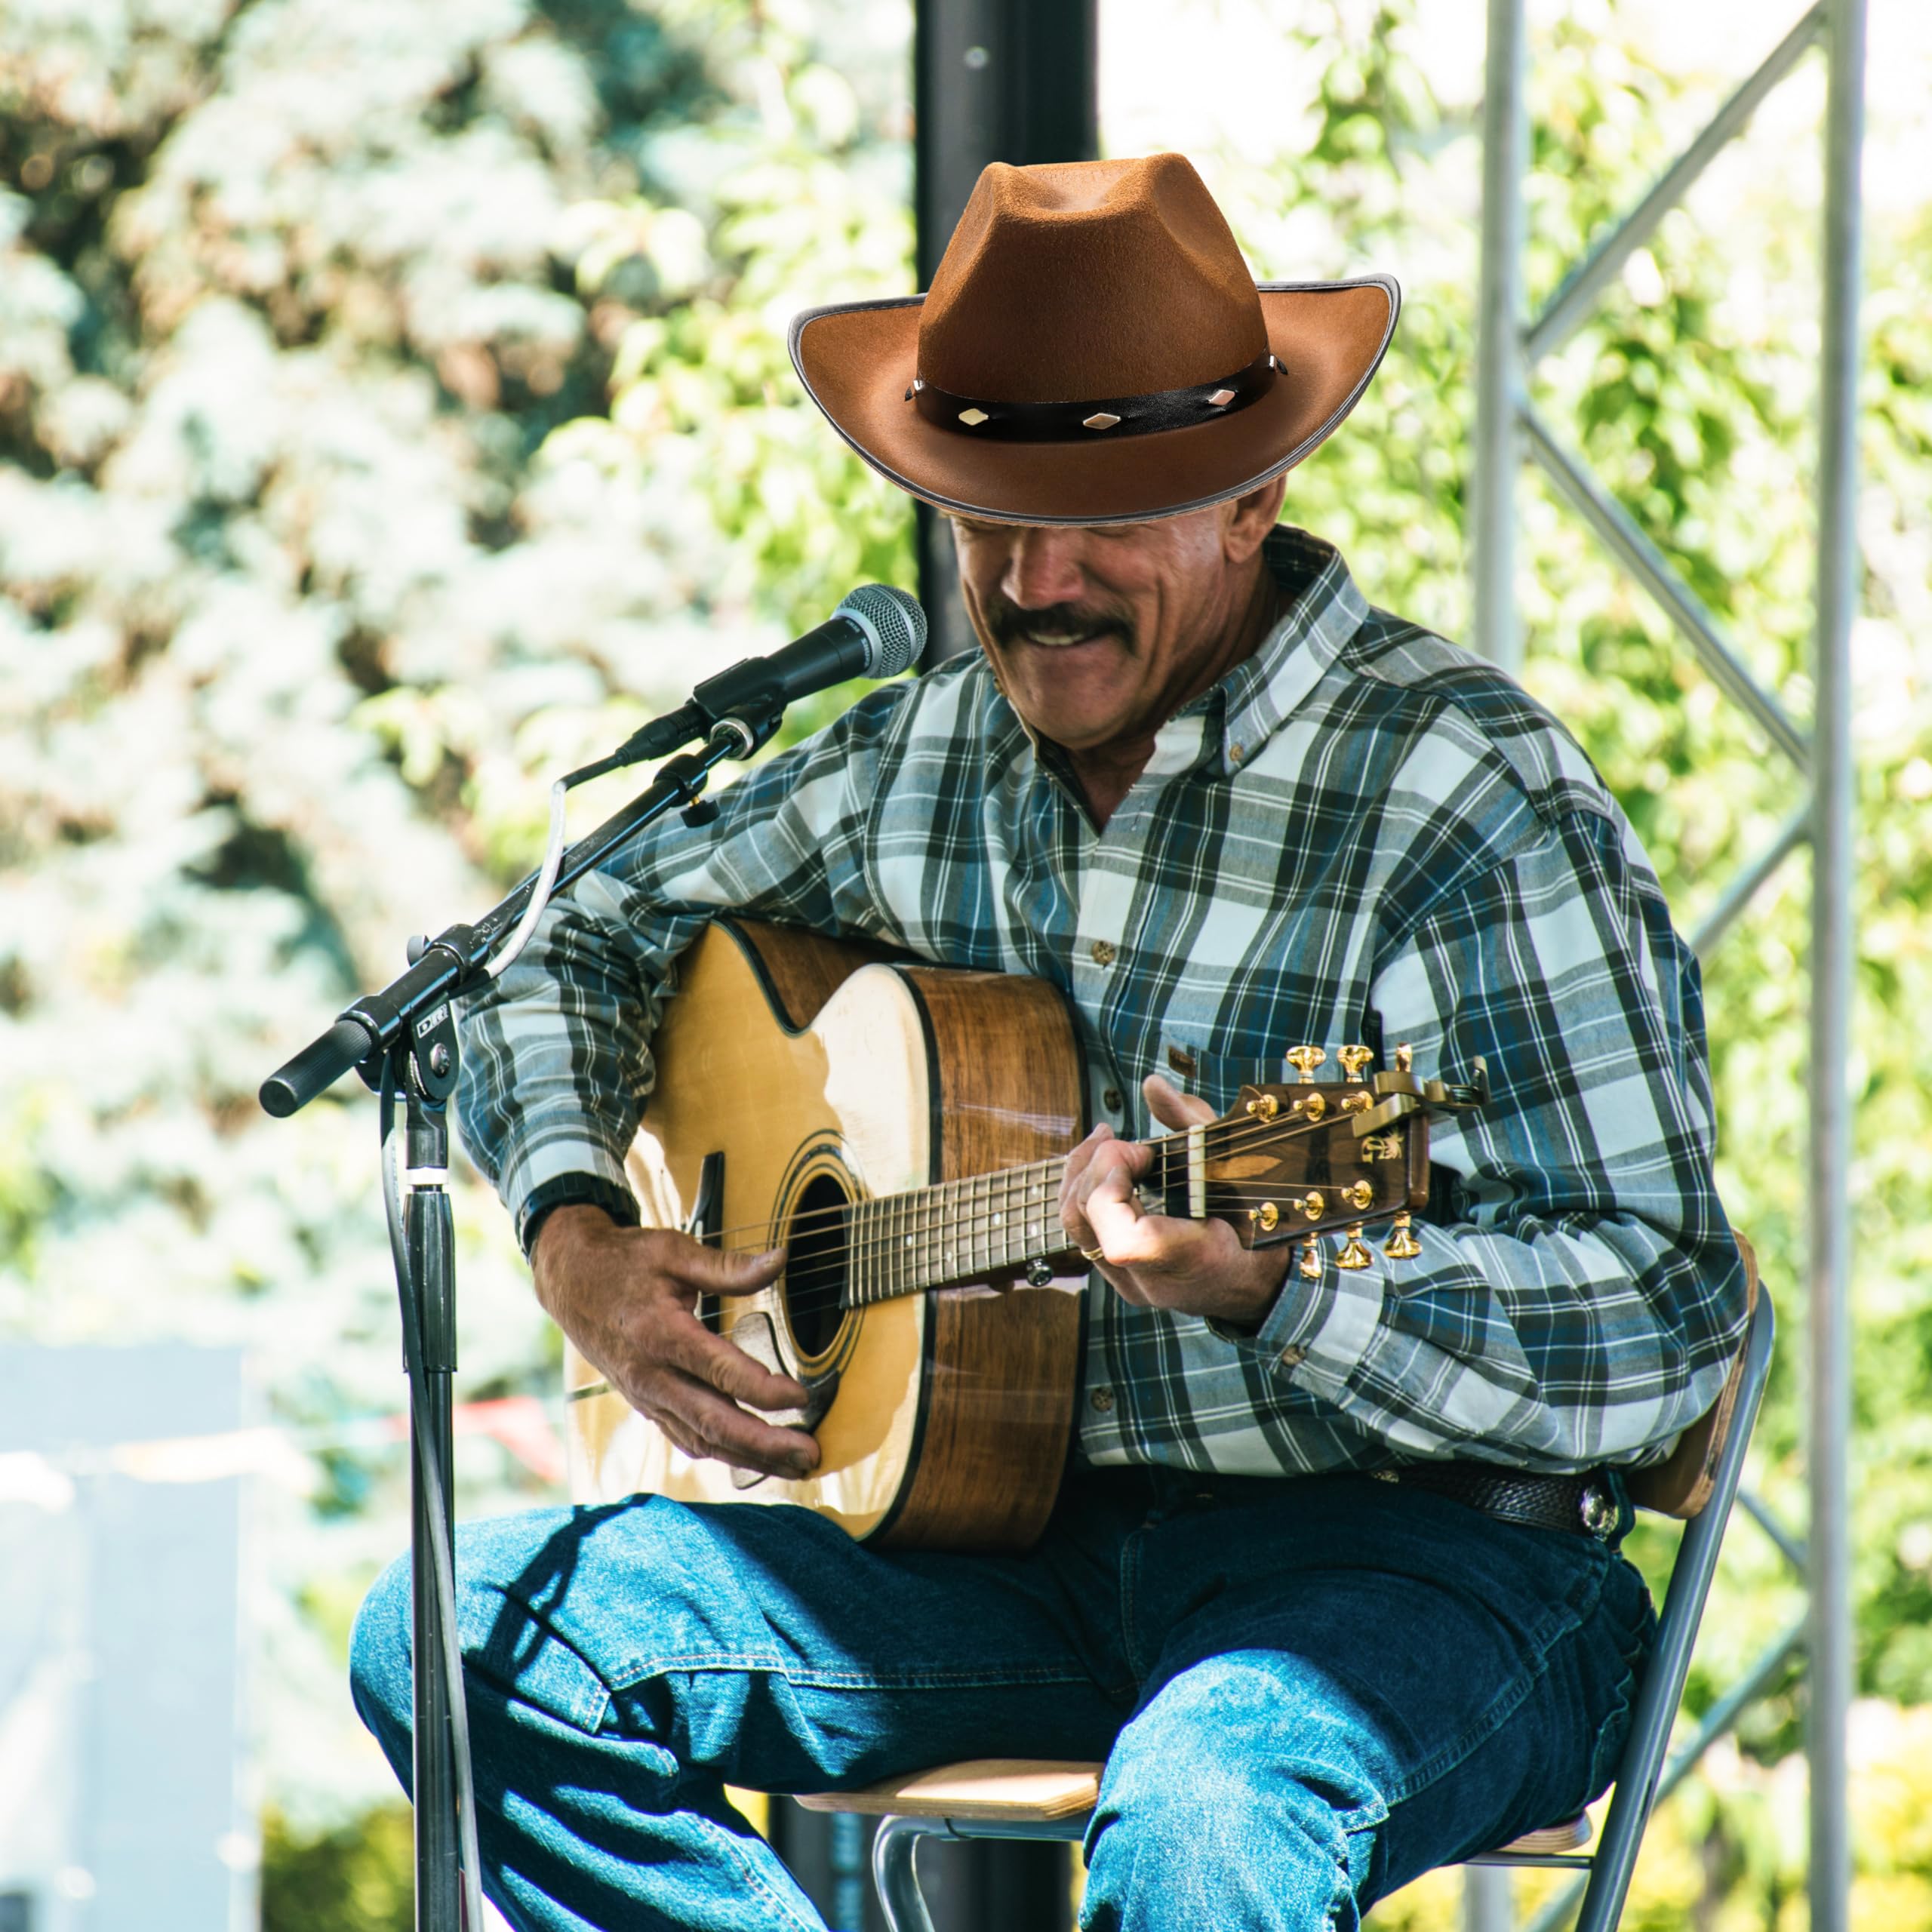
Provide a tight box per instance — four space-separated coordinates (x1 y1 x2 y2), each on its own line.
1469 0 1864 1932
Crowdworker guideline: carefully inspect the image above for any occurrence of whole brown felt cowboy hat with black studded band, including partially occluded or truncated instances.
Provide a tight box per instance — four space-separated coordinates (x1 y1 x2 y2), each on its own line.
790 155 1401 524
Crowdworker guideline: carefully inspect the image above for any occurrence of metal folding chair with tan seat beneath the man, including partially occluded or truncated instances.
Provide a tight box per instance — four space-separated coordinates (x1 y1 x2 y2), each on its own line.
798 1235 1776 1932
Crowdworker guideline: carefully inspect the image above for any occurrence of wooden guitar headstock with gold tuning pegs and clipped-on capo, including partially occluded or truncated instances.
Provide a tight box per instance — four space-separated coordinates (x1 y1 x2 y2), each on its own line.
1184 1045 1490 1279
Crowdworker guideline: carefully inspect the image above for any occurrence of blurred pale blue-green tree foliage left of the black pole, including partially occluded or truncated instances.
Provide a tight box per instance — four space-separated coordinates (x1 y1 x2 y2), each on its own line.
0 0 910 1884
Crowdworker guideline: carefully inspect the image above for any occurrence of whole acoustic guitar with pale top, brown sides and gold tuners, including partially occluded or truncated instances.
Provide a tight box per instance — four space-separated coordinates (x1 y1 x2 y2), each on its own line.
565 920 1487 1549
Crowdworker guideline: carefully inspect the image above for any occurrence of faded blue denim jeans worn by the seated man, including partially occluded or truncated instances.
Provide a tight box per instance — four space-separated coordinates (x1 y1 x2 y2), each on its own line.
352 1470 1654 1932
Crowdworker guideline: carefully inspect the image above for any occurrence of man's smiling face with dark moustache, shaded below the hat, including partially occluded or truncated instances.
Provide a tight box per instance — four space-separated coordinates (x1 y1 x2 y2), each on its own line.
952 485 1281 752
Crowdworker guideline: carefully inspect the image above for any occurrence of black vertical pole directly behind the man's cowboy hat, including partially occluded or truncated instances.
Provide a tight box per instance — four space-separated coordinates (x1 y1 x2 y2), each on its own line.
912 0 1100 663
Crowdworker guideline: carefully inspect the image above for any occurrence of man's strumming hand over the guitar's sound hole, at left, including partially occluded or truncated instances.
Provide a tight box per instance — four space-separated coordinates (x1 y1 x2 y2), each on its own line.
531 1204 819 1478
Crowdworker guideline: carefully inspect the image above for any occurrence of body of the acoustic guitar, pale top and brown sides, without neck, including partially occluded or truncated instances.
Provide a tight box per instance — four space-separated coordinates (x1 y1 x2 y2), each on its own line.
565 920 1086 1549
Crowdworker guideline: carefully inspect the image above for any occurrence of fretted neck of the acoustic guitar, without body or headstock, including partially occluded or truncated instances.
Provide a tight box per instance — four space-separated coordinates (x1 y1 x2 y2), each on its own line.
844 1134 1204 1308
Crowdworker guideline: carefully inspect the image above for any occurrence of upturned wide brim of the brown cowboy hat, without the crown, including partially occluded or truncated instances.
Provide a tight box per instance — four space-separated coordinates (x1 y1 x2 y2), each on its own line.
790 275 1403 524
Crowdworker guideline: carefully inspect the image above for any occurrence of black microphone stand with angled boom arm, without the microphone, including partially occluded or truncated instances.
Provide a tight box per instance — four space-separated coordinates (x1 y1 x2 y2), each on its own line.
261 703 784 1932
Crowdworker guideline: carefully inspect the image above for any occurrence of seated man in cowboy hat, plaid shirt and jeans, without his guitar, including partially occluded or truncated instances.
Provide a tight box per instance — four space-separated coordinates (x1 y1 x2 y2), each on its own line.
353 155 1745 1932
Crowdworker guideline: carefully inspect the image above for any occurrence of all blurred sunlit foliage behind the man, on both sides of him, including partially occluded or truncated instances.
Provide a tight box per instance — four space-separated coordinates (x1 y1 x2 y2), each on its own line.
0 0 1932 1928
